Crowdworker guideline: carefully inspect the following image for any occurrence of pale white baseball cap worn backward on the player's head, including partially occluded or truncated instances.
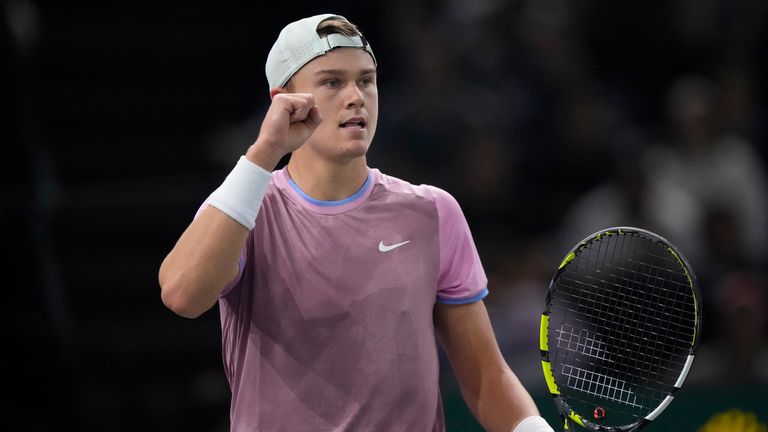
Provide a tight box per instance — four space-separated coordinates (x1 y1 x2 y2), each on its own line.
265 14 376 88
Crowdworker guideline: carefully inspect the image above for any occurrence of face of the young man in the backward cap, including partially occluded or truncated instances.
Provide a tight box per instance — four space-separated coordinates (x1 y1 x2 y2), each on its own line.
287 48 379 161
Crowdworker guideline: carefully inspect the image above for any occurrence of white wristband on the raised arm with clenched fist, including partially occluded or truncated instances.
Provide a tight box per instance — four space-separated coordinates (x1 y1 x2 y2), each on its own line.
208 156 272 231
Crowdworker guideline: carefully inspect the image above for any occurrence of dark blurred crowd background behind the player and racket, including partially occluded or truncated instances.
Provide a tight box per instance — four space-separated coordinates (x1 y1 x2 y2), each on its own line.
6 0 768 431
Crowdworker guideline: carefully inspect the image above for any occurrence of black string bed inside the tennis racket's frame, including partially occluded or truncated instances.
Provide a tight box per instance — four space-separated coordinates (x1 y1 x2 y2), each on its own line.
550 235 696 417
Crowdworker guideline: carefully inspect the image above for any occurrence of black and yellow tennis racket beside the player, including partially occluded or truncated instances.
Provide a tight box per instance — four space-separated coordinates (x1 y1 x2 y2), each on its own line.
540 227 701 432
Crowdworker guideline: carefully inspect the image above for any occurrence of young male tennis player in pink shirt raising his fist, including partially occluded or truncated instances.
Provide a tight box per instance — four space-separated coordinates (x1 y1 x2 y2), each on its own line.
159 14 552 432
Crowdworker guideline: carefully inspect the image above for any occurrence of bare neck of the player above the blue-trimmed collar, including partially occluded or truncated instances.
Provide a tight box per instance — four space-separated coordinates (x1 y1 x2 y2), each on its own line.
287 153 368 201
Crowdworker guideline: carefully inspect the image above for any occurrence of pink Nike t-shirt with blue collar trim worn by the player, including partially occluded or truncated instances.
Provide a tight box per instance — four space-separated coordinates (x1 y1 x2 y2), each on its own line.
219 169 488 432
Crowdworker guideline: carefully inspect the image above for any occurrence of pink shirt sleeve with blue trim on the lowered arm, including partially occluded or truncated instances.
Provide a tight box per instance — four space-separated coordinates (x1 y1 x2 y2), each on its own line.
435 188 488 304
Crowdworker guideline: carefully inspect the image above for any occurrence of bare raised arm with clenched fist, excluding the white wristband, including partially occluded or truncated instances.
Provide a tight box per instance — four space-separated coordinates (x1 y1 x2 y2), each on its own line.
158 89 322 318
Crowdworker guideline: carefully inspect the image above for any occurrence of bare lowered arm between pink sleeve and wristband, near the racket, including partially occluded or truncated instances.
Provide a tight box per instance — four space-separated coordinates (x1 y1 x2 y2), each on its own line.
434 301 552 432
